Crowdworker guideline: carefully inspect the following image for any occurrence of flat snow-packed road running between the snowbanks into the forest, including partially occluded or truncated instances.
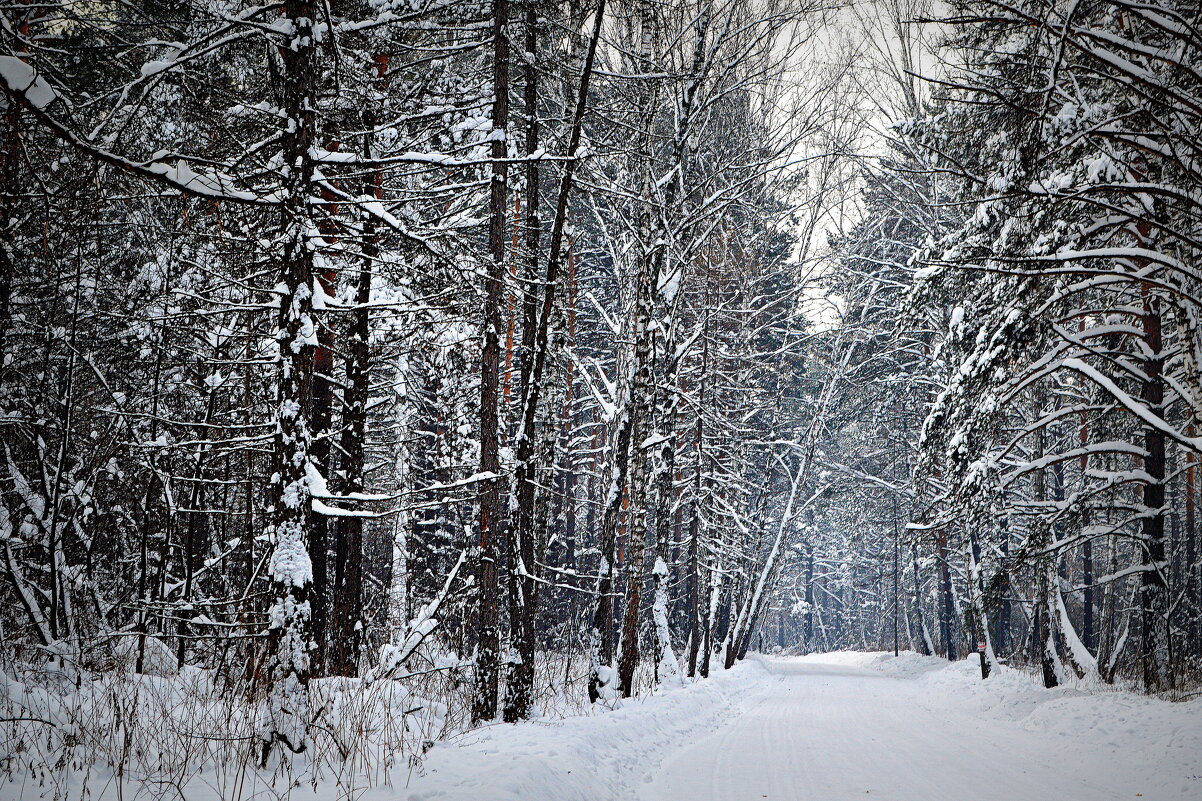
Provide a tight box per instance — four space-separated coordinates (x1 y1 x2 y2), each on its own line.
642 654 1149 801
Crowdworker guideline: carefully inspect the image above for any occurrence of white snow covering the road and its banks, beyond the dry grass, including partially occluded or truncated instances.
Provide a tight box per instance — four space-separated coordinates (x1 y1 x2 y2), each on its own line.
401 653 1202 801
